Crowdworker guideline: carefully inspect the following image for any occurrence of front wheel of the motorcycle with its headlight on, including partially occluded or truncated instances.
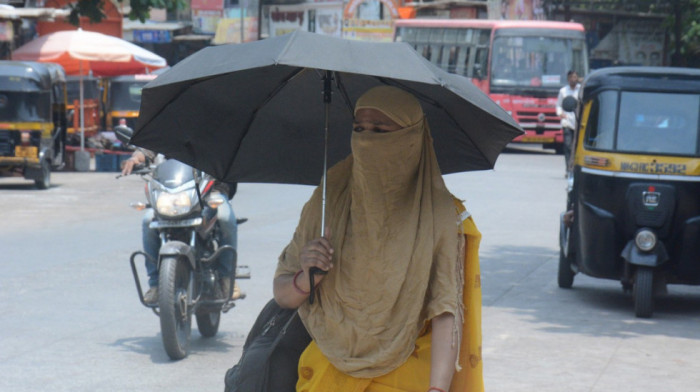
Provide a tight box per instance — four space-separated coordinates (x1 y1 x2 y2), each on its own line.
158 257 192 359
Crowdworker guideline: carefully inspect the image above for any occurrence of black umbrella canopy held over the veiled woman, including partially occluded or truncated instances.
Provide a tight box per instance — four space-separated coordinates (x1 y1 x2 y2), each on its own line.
132 32 522 185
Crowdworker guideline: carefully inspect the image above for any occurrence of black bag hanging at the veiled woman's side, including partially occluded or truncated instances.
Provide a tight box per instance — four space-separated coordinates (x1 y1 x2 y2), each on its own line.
224 299 311 392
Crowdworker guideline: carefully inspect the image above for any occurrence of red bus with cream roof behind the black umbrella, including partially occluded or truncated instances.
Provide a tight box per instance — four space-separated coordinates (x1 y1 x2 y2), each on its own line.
395 19 588 153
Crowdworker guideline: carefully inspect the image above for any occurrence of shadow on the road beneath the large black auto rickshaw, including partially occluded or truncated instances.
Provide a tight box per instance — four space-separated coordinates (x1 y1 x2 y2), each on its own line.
481 246 700 339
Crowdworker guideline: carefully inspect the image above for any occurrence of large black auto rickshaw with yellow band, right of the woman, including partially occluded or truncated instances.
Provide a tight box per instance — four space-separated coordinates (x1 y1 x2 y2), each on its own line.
558 67 700 317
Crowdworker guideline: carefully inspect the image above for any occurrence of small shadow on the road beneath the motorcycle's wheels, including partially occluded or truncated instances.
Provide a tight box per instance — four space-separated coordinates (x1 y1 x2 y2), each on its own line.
110 331 243 363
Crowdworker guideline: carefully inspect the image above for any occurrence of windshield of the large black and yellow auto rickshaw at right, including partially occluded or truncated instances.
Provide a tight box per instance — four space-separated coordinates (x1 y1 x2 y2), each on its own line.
584 90 700 156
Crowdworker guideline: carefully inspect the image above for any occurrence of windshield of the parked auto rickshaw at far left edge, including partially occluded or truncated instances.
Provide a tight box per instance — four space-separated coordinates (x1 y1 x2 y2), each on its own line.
0 91 52 122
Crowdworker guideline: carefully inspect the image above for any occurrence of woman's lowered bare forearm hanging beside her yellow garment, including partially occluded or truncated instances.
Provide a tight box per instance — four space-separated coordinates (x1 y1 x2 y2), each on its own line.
430 313 461 391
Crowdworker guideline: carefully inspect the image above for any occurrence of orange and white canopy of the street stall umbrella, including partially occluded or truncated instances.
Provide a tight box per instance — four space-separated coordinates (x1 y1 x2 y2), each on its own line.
12 29 167 76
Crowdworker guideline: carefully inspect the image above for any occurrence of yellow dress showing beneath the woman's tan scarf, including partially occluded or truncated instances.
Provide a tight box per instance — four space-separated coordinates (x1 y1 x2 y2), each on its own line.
296 202 484 392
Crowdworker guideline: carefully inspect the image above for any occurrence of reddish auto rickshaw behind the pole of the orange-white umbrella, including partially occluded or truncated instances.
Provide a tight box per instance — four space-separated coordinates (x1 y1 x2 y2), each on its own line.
66 75 104 146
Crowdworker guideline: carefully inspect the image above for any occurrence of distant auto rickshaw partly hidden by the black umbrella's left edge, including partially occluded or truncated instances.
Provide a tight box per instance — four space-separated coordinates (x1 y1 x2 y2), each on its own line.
106 74 158 130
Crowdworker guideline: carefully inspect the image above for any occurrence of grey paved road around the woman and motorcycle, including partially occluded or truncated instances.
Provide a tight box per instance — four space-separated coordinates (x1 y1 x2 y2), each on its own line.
0 152 700 392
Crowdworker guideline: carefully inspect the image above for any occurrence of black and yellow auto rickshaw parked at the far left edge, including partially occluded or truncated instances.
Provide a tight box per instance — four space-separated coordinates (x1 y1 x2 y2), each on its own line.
0 61 66 189
